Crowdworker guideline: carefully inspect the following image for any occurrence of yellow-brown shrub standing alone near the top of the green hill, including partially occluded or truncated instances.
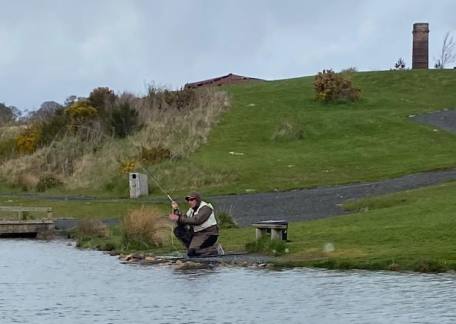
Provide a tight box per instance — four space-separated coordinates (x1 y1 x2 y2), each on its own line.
314 70 361 102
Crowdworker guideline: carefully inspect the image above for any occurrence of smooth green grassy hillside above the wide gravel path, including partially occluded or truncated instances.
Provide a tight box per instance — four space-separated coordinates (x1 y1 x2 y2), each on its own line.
153 70 456 194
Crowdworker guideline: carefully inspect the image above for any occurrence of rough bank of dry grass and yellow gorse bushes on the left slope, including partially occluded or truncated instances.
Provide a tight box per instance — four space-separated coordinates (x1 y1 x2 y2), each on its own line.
0 87 229 193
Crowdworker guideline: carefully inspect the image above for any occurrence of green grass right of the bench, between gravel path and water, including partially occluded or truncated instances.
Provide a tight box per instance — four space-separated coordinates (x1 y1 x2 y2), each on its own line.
262 182 456 271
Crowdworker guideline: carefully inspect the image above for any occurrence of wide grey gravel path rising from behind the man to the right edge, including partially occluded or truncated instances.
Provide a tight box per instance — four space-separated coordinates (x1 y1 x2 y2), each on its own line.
212 170 456 226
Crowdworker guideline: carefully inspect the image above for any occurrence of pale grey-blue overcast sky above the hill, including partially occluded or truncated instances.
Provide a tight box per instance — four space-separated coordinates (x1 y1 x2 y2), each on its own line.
0 0 456 110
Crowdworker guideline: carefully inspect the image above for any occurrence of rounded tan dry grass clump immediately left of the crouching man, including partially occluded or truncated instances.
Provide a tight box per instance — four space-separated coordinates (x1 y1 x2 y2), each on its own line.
121 206 170 250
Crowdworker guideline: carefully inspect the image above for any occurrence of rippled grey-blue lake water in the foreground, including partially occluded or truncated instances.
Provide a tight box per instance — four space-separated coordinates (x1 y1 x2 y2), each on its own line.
0 240 456 324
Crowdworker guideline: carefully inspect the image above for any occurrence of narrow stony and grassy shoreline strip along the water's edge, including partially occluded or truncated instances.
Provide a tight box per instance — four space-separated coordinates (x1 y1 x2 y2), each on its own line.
9 233 456 274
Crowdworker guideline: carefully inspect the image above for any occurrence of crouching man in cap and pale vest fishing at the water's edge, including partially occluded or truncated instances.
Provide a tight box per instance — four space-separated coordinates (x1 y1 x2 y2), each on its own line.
169 192 224 257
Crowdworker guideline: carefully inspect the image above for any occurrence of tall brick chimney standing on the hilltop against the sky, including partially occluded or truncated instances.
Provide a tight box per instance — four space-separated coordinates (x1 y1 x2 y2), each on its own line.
412 23 429 69
